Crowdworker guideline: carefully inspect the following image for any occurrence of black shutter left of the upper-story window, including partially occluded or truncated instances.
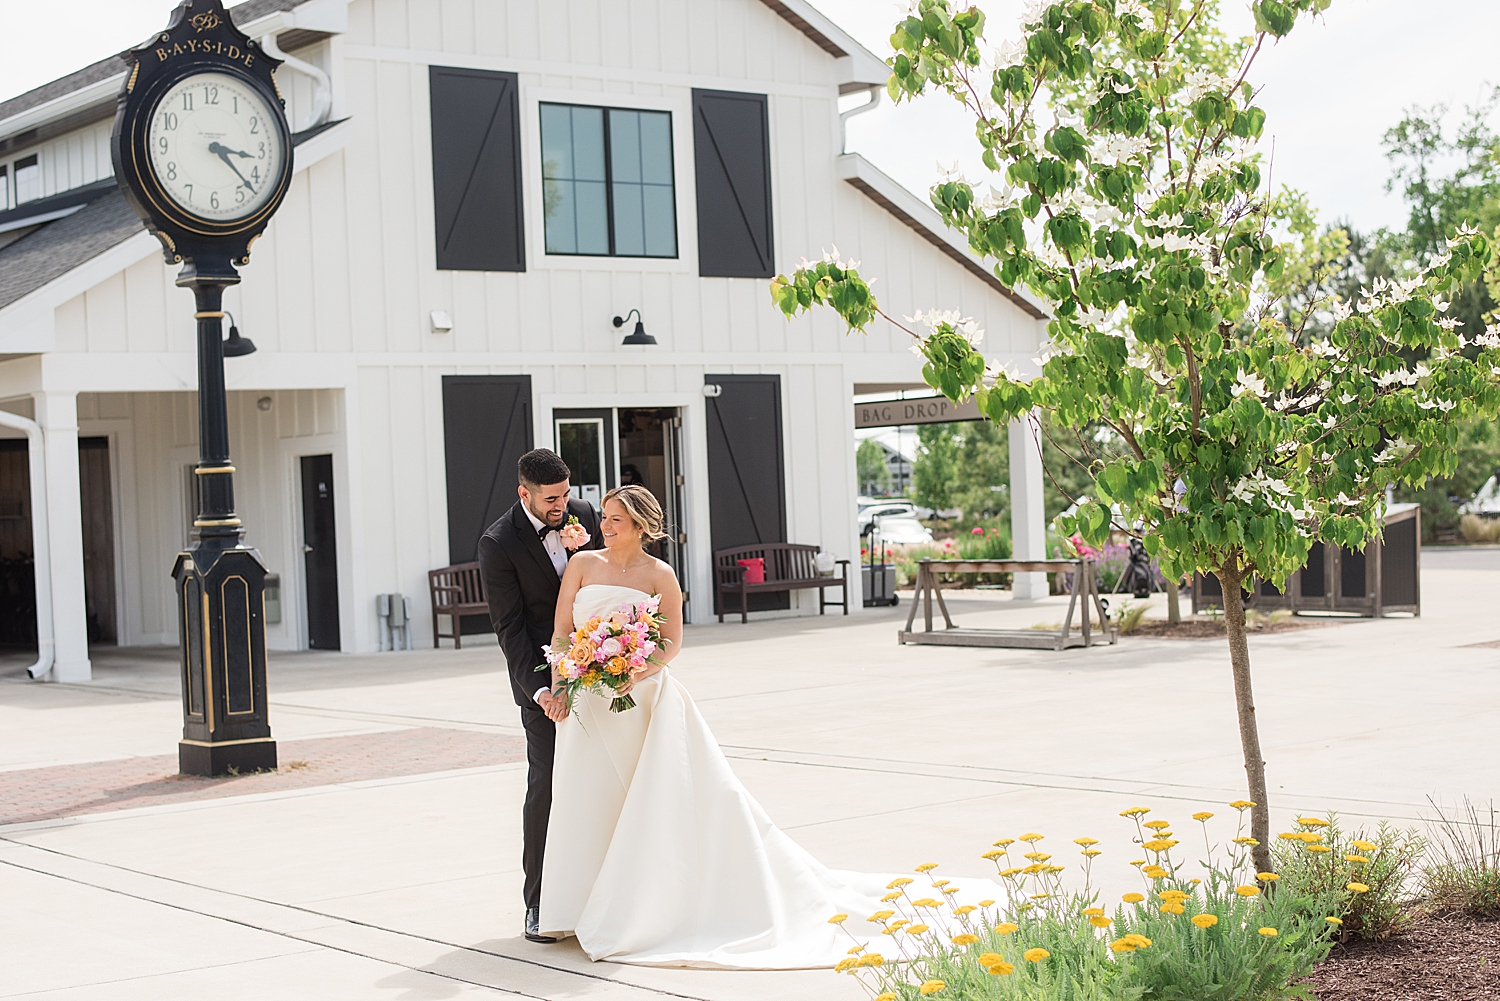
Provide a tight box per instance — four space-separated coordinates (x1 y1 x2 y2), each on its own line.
428 66 527 272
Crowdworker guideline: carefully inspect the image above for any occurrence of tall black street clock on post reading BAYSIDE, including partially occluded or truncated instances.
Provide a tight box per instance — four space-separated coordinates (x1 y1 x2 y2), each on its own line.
110 0 291 776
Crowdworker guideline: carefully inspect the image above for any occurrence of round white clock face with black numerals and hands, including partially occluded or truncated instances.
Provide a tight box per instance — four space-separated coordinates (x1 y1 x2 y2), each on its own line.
147 72 287 222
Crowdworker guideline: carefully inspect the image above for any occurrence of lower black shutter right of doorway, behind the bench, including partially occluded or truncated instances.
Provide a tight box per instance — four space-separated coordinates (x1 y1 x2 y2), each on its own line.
704 375 791 611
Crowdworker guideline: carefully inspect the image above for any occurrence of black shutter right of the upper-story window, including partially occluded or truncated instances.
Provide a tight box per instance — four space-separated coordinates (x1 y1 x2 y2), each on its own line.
693 90 776 278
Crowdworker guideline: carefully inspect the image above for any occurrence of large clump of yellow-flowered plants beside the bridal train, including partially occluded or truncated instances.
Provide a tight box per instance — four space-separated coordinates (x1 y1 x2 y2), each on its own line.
833 801 1350 1001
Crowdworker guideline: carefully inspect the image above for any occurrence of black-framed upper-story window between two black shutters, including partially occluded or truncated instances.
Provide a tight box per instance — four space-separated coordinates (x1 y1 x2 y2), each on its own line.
540 104 677 257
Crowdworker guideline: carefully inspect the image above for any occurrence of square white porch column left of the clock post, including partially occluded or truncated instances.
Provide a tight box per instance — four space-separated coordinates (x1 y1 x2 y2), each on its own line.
32 392 93 681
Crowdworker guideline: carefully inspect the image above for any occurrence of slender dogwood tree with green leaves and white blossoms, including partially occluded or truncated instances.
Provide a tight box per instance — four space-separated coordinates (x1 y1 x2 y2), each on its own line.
771 0 1500 872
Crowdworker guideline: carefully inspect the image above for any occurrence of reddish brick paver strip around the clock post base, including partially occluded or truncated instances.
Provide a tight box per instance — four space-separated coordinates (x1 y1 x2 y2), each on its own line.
0 726 527 824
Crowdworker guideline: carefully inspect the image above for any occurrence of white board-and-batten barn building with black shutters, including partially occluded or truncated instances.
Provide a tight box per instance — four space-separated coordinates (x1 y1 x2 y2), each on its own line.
0 0 1044 680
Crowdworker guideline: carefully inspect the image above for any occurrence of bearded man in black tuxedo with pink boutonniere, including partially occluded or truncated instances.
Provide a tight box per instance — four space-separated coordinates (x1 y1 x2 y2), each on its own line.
479 449 600 942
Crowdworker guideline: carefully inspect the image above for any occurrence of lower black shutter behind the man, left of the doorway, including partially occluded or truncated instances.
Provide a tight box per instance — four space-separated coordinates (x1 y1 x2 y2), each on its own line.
443 375 531 563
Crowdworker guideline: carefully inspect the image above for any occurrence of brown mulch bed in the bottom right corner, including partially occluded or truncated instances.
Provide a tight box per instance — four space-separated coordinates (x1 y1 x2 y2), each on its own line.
1302 917 1500 1001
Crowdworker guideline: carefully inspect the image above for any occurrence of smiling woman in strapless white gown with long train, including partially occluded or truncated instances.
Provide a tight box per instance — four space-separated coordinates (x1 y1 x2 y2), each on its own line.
540 485 888 969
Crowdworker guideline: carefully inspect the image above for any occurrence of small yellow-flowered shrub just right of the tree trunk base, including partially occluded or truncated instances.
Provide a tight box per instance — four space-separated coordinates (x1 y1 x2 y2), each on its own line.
1272 813 1427 938
